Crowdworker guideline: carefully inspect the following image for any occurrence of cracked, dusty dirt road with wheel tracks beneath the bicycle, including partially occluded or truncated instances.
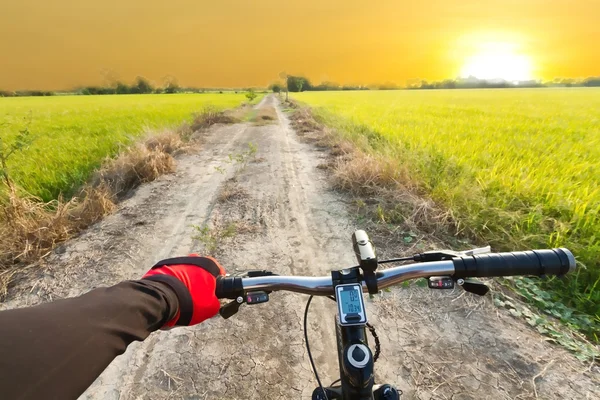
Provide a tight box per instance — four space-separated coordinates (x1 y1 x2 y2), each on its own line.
3 96 600 400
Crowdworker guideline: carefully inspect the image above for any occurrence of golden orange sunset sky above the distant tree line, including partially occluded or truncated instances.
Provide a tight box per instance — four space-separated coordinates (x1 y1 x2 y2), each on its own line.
0 0 600 90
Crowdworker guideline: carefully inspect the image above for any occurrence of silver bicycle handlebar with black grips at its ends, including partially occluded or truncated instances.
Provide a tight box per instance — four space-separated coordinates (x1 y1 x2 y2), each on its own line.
216 248 576 299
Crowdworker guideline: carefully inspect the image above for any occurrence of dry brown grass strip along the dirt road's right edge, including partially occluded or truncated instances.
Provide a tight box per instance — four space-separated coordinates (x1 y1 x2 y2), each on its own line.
291 107 456 236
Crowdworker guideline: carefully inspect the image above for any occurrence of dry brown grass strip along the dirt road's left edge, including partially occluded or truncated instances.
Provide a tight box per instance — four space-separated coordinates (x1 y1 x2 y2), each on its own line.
0 128 191 297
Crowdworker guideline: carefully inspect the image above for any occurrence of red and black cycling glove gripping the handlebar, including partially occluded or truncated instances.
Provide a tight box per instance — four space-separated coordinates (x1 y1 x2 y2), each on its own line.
142 254 225 328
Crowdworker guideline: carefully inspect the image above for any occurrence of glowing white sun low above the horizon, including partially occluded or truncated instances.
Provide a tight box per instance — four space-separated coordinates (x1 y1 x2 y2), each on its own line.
461 43 533 82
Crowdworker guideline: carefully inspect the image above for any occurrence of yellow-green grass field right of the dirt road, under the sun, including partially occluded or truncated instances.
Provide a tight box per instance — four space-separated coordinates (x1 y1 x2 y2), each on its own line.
293 88 600 324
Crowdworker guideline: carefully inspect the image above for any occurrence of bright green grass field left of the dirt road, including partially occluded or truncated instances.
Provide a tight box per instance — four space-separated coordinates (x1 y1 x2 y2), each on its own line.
0 93 246 201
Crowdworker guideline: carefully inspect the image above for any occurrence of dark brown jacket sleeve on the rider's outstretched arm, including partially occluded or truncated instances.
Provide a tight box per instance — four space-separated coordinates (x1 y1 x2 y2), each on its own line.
0 280 178 399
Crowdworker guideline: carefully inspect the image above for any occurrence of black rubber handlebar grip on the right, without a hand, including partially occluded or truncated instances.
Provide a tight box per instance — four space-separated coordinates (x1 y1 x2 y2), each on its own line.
452 248 576 278
